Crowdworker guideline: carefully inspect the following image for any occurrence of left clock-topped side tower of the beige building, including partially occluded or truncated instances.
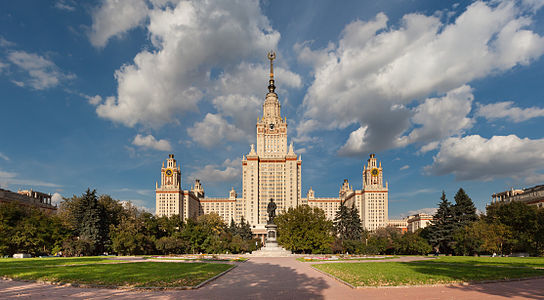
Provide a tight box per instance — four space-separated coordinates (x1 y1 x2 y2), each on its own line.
155 154 184 217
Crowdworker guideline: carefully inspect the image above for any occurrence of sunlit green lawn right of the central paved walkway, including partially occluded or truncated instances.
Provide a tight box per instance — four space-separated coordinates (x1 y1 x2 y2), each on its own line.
313 257 544 286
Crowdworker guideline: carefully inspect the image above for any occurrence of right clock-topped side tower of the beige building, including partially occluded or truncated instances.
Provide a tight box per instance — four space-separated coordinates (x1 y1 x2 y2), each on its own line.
360 154 389 231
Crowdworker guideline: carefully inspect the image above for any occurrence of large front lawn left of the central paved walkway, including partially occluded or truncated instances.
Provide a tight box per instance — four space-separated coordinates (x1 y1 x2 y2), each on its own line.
0 262 233 287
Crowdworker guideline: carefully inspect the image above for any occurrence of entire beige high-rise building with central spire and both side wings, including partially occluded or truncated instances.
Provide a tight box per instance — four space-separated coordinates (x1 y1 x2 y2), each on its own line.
156 52 388 235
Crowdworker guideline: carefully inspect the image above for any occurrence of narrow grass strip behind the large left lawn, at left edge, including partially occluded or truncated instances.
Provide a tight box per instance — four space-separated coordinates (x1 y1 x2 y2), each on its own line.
0 256 119 269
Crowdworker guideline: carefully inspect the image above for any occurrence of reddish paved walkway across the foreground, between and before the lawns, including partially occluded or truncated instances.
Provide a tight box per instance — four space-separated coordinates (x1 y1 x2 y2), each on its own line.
0 257 544 300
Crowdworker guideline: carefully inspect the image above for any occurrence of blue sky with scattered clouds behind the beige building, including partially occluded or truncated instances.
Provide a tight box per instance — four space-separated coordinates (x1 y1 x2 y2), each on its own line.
0 0 544 218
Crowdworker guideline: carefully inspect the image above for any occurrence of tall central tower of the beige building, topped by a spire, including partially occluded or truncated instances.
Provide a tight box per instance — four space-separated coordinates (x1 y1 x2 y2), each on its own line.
238 51 302 233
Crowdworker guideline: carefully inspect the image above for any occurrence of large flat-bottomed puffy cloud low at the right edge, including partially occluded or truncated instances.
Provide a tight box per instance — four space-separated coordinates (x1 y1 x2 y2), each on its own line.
424 135 544 181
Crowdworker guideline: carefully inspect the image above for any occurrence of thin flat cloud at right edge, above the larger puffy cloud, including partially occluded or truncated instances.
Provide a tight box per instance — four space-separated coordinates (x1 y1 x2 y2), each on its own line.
476 101 544 123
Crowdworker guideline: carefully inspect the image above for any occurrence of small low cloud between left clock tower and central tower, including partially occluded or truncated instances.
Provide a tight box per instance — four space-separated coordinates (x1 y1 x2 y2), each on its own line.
188 159 242 182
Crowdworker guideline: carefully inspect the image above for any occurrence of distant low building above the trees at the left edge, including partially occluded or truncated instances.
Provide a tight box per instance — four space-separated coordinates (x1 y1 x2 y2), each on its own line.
0 189 57 213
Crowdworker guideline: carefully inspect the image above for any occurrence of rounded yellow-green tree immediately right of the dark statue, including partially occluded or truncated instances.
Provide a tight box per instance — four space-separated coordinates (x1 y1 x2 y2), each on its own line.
275 205 334 253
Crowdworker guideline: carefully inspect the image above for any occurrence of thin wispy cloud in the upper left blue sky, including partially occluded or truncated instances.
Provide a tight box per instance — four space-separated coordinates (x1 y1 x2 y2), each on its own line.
7 51 75 90
